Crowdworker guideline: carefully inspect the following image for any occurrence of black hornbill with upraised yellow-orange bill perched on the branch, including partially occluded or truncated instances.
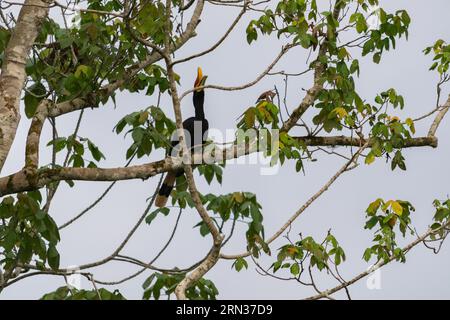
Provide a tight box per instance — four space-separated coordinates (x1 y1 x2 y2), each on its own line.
155 67 209 208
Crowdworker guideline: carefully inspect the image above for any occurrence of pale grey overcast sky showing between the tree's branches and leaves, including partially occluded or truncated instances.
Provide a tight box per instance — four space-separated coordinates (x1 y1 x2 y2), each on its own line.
1 0 450 299
